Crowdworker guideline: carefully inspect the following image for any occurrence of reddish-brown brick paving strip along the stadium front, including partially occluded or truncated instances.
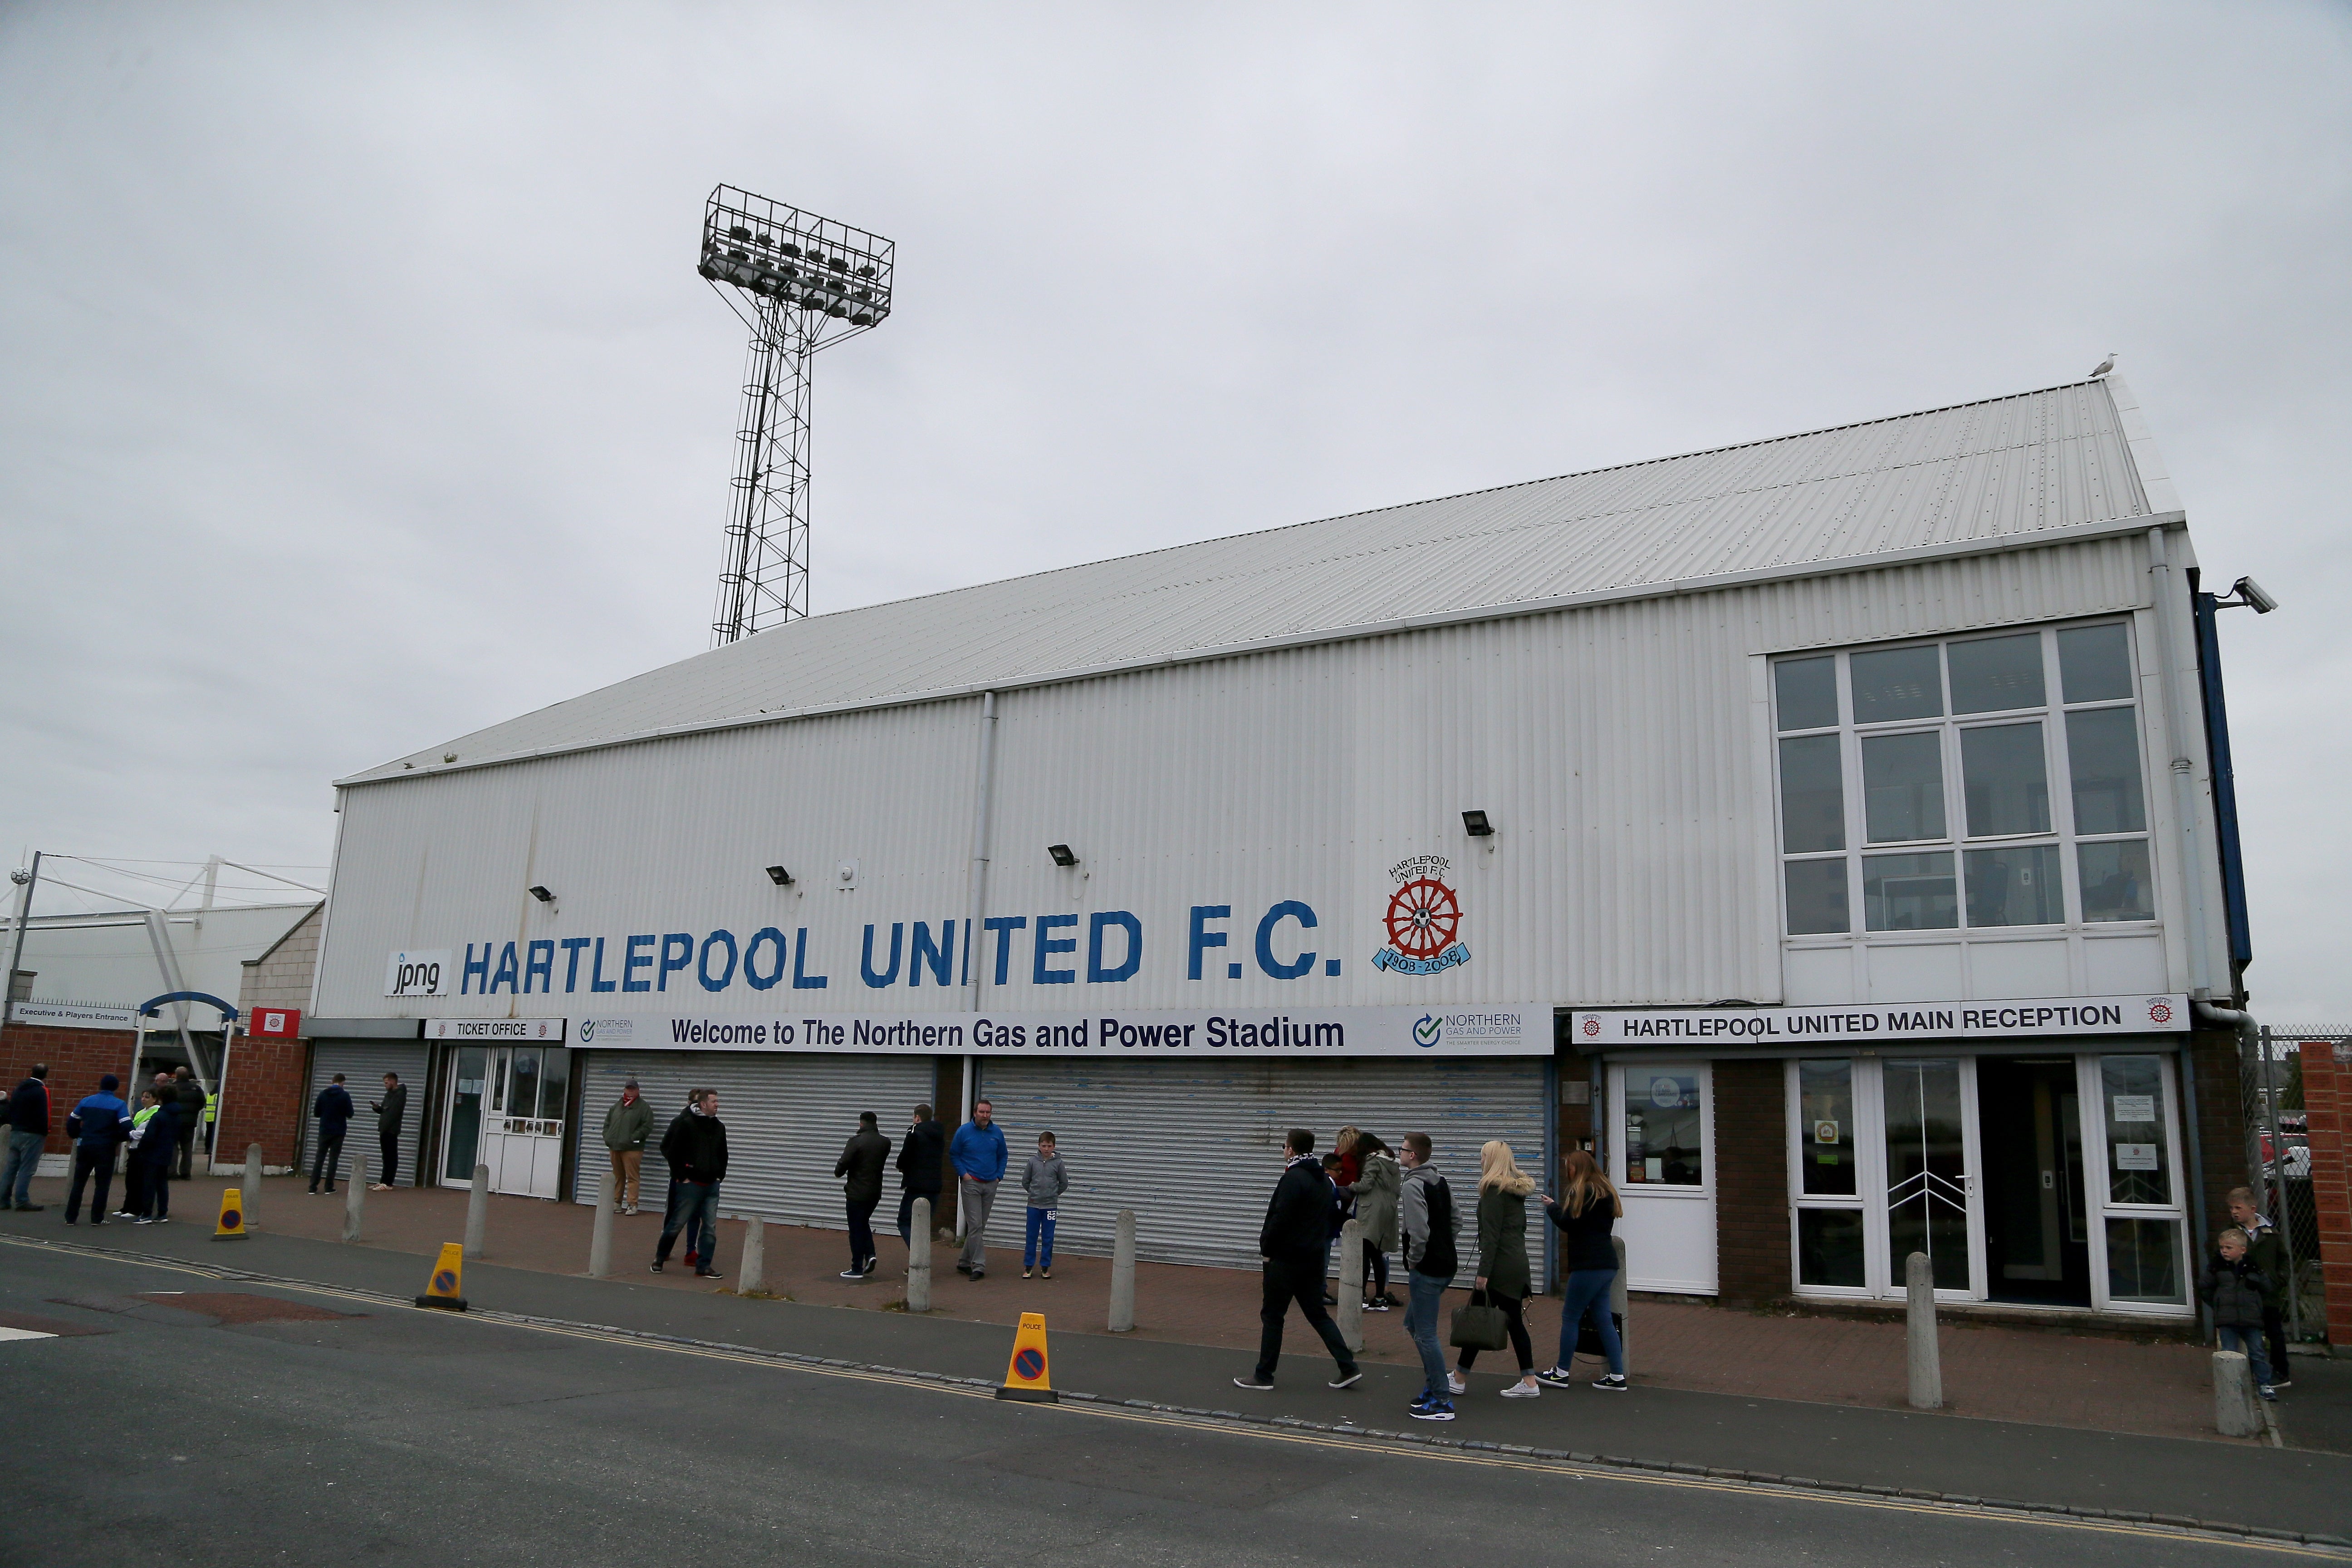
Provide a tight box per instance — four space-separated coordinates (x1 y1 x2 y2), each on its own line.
0 1178 2267 1441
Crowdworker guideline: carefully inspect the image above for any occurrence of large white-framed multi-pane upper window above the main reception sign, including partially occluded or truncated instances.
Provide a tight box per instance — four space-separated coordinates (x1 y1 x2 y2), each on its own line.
1774 621 2157 936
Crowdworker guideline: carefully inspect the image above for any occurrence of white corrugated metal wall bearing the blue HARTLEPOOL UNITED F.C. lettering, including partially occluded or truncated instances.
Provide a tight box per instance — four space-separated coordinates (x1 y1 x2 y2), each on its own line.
318 539 2197 1015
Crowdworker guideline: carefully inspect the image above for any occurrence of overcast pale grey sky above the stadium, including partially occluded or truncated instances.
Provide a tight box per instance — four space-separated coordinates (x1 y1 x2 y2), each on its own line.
0 2 2352 1023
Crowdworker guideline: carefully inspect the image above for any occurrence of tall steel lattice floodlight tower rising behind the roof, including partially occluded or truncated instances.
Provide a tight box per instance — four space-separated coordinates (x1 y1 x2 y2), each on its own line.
696 186 896 647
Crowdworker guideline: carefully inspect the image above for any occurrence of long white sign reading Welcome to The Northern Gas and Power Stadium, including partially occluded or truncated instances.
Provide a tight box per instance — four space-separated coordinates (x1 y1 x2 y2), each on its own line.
555 1006 1552 1055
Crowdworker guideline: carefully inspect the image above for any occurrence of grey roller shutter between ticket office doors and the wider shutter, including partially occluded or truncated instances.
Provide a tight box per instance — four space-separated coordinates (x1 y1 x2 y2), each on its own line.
574 1051 936 1230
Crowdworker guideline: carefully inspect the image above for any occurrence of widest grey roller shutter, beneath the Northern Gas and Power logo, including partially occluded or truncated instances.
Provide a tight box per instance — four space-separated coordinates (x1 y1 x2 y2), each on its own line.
981 1058 1548 1295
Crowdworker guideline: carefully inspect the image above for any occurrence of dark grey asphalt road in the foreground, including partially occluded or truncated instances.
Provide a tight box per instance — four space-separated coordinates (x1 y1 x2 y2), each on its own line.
0 1248 2322 1568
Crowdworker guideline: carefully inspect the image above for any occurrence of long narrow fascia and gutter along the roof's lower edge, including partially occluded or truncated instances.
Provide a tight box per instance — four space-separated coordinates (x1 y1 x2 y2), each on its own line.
334 510 2187 790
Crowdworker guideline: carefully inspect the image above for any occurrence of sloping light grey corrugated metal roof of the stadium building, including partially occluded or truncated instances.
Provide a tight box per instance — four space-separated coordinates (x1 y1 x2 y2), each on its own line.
343 381 2171 783
